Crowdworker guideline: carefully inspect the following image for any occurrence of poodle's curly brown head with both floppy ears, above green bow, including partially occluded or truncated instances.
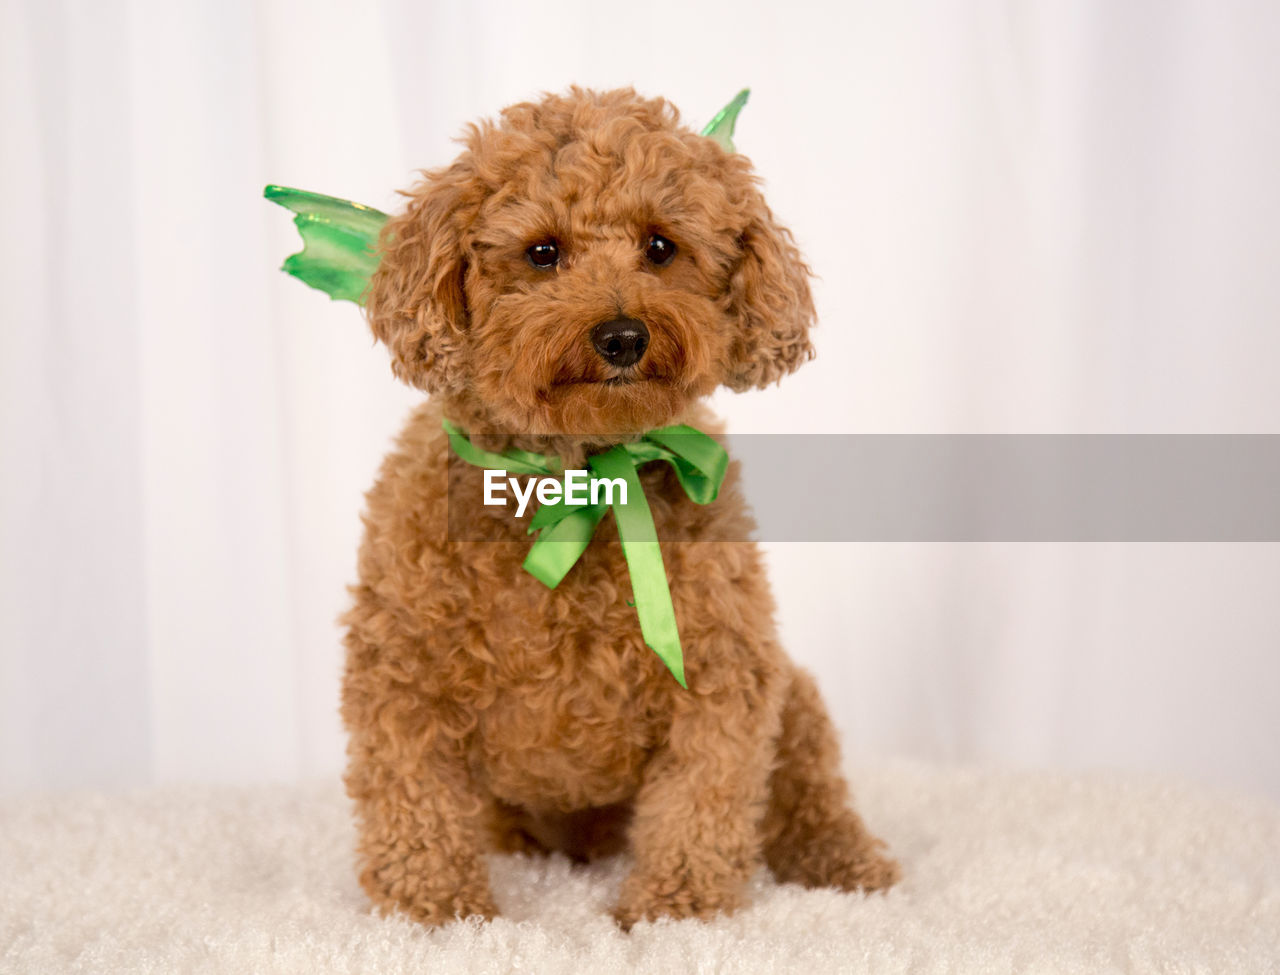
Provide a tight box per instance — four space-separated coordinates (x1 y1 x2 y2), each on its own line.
366 90 813 436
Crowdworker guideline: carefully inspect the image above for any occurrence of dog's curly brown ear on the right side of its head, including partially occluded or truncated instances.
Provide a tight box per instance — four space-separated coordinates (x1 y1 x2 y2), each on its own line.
724 187 814 390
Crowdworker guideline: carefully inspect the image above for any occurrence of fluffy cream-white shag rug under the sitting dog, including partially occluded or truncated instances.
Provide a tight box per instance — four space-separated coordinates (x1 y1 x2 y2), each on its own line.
0 764 1280 975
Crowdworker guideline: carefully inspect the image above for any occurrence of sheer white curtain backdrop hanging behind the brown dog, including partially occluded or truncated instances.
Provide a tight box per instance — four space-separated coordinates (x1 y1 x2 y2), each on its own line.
0 0 1280 797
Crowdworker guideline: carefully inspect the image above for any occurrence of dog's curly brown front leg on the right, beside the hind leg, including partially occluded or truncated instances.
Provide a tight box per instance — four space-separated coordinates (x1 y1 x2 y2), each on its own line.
613 690 778 929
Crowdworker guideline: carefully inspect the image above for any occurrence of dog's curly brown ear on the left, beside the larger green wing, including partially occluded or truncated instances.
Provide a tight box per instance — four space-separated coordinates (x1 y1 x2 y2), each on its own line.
365 160 475 393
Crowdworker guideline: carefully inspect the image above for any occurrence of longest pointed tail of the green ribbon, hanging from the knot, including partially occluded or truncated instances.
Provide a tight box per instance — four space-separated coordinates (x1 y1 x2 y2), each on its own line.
588 447 689 690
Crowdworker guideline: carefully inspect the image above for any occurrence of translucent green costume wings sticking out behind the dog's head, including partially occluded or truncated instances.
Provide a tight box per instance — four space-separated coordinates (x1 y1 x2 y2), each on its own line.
262 88 751 305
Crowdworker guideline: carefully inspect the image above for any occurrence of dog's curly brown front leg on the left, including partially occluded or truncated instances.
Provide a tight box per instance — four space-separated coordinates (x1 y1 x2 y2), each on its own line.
347 706 497 924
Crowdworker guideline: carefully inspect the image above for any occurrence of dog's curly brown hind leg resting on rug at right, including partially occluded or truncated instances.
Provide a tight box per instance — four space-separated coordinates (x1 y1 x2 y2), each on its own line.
762 669 899 891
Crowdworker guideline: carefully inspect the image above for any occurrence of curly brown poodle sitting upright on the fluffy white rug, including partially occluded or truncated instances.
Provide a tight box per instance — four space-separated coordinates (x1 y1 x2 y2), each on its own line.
342 88 897 928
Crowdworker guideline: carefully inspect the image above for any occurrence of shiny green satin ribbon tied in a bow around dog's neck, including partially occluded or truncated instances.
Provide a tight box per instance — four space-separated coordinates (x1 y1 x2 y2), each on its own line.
444 420 728 688
